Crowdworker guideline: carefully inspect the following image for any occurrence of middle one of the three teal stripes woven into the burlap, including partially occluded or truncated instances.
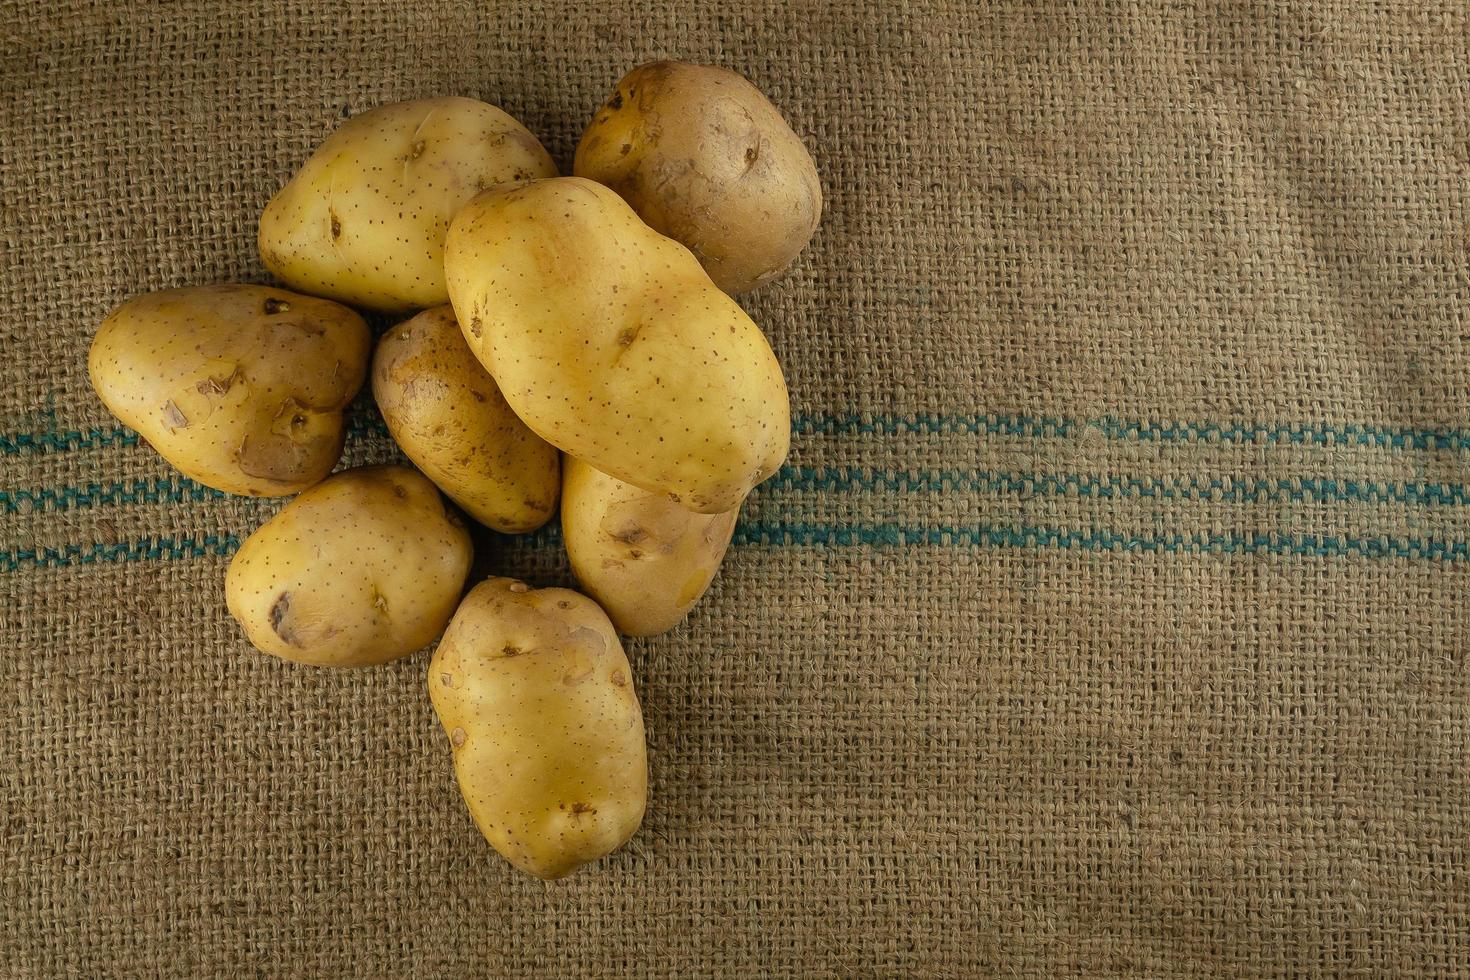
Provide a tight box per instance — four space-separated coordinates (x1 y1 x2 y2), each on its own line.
11 466 1470 514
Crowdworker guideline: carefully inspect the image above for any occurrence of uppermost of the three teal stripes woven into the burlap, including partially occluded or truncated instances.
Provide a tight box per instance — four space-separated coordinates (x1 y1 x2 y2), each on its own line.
11 413 1470 455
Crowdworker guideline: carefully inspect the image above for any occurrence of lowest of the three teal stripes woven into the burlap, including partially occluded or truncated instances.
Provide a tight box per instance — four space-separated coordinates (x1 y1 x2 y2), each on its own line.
0 523 1470 572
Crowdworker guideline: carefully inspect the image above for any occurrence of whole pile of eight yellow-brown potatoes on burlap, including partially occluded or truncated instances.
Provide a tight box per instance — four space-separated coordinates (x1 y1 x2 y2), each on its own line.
88 62 822 879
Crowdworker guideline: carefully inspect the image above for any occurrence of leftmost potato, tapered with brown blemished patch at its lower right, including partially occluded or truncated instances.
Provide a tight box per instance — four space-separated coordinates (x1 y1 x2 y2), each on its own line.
87 285 372 497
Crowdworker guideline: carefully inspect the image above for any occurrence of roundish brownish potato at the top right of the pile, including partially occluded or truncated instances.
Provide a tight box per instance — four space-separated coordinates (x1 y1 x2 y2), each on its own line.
572 62 822 292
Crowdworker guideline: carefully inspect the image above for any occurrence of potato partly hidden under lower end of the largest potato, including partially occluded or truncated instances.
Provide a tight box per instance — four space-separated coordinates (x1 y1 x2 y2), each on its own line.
562 457 739 636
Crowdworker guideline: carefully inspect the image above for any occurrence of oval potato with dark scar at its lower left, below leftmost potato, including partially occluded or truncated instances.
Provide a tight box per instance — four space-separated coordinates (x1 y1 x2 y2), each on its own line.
225 466 472 667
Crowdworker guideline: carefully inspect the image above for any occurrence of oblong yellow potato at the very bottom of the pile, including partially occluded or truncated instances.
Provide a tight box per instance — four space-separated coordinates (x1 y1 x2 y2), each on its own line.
429 579 648 879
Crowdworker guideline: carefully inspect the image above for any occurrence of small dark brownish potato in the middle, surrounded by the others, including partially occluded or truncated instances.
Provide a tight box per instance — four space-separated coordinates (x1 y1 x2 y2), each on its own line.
372 306 562 533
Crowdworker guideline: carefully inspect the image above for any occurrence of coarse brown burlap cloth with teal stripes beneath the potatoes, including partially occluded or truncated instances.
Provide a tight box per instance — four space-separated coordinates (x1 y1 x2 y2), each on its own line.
0 0 1470 977
